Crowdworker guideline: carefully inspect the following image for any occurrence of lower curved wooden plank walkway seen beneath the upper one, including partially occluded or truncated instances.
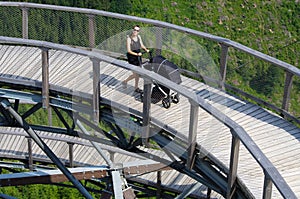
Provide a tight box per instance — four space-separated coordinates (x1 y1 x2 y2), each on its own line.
0 127 216 198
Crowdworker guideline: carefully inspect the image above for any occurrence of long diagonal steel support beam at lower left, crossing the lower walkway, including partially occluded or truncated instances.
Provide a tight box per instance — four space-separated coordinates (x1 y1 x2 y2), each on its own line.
0 98 93 199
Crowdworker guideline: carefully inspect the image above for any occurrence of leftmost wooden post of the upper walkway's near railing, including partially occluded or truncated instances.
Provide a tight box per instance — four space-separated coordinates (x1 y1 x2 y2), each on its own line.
42 48 49 109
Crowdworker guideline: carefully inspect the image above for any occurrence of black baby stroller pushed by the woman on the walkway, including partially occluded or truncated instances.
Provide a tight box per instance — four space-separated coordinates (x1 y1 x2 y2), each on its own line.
142 52 182 108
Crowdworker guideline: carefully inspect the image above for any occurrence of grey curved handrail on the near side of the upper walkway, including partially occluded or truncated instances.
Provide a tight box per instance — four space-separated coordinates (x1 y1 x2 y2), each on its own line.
0 36 296 198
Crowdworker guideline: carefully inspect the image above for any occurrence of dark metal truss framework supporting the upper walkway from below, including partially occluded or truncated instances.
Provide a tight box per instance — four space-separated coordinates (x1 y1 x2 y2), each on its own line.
0 89 250 198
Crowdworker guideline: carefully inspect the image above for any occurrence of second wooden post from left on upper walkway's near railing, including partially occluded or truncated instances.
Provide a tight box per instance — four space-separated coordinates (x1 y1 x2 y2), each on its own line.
91 58 101 123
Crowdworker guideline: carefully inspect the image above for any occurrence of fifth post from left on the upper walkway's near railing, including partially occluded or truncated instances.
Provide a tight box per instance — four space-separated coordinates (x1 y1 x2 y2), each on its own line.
226 130 240 199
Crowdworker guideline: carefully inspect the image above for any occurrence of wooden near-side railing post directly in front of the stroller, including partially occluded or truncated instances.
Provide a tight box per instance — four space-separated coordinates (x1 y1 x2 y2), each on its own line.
142 78 152 146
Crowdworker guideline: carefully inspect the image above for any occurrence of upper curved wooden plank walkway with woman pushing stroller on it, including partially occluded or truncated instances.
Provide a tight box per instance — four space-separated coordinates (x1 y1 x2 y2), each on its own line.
0 45 300 198
